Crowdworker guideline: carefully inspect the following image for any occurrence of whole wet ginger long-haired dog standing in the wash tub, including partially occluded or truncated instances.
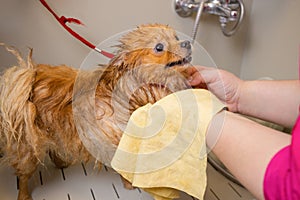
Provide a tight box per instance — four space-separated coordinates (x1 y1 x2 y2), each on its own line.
0 24 191 200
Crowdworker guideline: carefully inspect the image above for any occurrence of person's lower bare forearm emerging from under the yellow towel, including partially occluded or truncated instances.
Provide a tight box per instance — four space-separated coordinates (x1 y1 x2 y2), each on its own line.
206 111 291 199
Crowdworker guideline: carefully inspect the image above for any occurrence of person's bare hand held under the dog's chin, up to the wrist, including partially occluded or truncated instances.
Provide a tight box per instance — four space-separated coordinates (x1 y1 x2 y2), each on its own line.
187 66 244 112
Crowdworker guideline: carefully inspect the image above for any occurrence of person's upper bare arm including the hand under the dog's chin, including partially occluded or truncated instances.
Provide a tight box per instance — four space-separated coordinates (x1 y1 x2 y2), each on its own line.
187 66 300 127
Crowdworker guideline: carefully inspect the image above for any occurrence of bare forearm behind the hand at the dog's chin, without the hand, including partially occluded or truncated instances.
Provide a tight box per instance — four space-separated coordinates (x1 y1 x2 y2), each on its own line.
237 80 300 127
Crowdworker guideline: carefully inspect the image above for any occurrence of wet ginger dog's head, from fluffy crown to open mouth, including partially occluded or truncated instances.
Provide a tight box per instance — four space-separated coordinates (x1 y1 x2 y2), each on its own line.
111 24 192 68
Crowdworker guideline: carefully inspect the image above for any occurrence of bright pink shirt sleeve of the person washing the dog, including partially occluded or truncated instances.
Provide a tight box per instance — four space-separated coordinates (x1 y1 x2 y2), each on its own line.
264 115 300 200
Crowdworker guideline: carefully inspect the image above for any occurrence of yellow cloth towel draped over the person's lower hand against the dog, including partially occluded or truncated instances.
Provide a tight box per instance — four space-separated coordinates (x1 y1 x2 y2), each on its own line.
111 89 225 200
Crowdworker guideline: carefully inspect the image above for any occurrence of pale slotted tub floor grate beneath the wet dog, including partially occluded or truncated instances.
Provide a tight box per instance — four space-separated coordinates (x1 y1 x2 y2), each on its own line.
0 163 254 200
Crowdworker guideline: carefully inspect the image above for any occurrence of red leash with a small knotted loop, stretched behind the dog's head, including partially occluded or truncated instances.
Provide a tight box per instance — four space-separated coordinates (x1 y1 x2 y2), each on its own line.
40 0 114 58
